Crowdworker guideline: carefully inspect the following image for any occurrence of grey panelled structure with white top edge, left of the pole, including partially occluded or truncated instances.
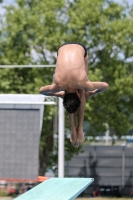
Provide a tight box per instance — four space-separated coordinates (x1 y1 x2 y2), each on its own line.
0 94 49 180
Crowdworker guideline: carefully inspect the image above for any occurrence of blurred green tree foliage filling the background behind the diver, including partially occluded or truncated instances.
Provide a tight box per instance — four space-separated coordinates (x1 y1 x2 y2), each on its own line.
0 0 133 173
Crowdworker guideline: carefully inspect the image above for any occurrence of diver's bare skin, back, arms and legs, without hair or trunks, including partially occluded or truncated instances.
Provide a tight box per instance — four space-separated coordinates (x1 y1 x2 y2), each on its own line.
40 44 108 146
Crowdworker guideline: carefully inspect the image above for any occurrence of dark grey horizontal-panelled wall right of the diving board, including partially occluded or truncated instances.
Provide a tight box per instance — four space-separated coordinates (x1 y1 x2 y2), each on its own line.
65 145 133 195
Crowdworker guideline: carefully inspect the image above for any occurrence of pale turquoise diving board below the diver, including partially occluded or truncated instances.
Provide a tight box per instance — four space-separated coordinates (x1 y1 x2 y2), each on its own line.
14 178 94 200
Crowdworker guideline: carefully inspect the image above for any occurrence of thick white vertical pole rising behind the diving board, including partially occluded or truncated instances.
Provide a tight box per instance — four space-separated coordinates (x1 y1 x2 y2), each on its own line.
58 98 64 178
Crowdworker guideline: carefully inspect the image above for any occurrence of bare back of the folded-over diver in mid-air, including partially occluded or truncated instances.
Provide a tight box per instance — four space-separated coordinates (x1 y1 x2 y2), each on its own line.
54 44 88 87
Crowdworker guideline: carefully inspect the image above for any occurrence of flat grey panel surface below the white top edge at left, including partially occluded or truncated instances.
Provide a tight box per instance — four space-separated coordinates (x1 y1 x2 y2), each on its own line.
0 109 40 179
